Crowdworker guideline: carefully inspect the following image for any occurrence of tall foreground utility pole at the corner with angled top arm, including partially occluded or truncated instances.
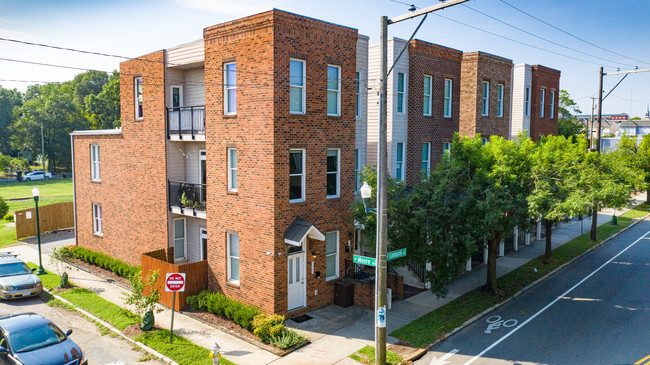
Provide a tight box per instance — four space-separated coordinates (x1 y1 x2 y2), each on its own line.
375 0 469 365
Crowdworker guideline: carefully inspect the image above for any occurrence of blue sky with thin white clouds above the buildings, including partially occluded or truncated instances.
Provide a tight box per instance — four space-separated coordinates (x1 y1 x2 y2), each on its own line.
0 0 650 117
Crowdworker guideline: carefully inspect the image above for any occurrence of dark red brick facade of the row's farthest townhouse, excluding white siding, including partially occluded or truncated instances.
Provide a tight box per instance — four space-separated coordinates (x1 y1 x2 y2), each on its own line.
530 65 560 141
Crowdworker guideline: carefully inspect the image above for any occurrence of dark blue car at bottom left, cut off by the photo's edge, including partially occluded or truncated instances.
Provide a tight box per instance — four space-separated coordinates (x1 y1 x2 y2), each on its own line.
0 313 88 365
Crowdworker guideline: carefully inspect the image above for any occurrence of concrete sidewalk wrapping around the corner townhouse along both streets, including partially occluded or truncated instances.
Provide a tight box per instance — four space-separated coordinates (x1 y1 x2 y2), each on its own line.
0 193 646 365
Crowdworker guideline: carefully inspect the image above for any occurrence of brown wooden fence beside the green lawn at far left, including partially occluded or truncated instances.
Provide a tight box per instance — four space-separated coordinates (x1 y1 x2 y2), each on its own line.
15 202 74 239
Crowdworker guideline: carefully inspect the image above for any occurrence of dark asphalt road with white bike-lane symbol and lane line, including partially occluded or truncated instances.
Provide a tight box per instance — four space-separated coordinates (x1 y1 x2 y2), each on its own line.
417 221 650 365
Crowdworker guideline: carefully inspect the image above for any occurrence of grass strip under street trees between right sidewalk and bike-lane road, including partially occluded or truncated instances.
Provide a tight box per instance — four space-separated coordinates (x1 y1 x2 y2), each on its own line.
391 204 650 347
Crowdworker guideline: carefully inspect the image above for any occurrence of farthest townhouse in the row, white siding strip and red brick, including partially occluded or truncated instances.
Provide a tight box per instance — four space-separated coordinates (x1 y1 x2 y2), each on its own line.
510 63 561 141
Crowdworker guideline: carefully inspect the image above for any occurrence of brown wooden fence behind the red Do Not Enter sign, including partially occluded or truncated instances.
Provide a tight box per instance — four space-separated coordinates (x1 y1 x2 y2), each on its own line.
142 249 208 311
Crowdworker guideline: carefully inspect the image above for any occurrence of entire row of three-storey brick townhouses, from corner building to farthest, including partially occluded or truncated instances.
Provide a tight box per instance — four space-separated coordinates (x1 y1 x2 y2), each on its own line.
72 10 560 316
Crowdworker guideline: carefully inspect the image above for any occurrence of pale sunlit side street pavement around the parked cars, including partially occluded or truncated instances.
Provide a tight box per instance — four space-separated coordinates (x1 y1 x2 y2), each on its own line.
0 297 165 365
